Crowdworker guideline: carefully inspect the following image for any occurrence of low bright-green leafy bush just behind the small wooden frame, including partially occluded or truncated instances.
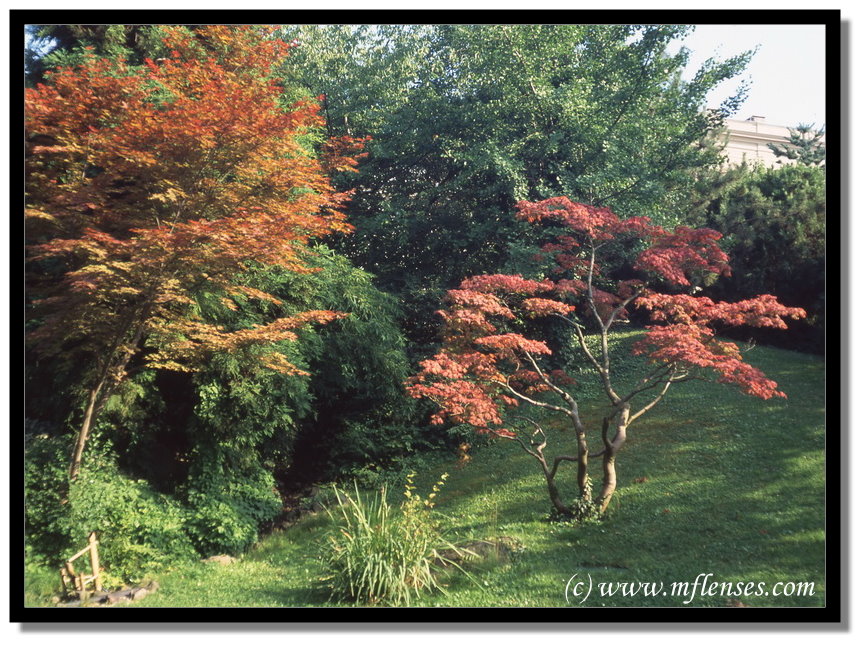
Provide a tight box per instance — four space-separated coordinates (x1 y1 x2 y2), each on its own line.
67 443 197 582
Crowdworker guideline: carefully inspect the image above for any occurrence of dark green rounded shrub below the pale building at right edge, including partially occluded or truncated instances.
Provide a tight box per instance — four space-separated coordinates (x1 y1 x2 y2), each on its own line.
689 164 826 352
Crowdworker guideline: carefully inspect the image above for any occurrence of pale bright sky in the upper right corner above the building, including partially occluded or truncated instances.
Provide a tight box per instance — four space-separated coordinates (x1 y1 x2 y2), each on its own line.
676 25 826 128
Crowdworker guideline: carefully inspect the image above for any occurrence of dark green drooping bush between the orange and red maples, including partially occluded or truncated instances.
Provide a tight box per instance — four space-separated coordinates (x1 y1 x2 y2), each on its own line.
281 247 422 479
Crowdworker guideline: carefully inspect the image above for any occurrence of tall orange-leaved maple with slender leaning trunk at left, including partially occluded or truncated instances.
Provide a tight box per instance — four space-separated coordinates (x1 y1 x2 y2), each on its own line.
25 26 358 478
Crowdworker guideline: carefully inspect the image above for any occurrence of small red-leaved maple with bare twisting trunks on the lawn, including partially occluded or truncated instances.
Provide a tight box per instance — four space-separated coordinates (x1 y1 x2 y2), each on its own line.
408 197 805 514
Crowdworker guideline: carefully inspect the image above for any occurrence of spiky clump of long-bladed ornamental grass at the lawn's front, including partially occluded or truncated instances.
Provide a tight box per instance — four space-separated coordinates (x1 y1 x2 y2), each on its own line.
322 474 460 606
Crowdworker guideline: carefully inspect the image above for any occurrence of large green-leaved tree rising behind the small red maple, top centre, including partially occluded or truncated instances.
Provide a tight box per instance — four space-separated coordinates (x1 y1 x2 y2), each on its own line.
286 25 749 344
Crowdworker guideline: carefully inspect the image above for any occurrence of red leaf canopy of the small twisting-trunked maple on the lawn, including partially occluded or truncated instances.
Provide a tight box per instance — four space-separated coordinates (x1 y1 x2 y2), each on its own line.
409 198 805 436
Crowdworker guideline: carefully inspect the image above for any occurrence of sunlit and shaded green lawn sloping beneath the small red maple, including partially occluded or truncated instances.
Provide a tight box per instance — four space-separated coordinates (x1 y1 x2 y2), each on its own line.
25 333 825 607
